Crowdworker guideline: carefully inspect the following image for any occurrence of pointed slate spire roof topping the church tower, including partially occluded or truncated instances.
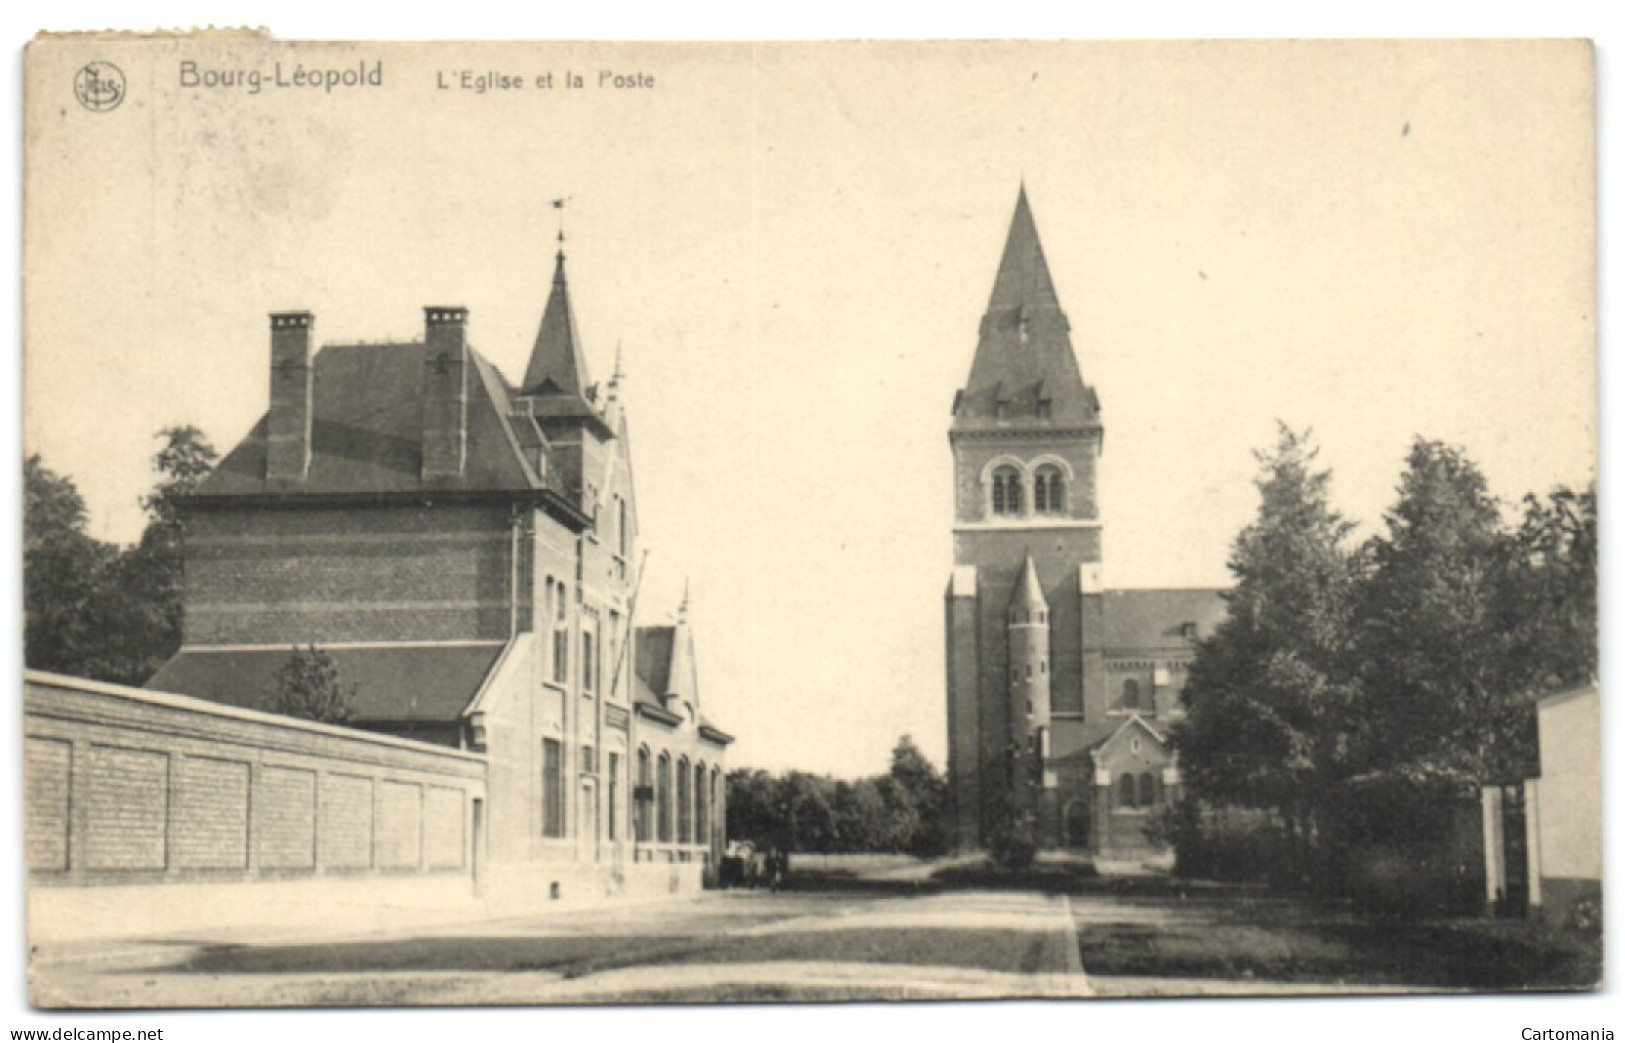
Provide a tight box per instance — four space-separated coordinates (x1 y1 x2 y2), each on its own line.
954 187 1100 431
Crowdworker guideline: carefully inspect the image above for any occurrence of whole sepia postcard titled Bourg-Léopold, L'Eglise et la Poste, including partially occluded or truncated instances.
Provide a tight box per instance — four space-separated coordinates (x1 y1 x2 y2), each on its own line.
10 29 1612 1020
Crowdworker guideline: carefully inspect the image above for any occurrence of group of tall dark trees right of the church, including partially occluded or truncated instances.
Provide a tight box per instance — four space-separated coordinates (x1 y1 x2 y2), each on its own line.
1175 426 1597 872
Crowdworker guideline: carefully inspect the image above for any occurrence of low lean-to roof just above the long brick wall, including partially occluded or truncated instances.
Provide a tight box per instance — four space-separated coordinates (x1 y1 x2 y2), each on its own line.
143 645 502 723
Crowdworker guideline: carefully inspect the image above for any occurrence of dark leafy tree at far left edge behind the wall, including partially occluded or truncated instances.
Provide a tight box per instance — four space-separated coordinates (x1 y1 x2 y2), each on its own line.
23 453 115 676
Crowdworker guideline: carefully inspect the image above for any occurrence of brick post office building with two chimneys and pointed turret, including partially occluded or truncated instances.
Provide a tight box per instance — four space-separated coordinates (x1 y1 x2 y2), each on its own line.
148 252 731 894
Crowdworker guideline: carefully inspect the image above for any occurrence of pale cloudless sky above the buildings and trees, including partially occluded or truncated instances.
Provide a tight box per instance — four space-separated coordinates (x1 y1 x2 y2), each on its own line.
24 42 1597 775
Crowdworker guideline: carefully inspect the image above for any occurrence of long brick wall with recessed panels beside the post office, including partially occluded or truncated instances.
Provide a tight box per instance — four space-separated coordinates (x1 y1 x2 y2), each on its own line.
24 671 488 884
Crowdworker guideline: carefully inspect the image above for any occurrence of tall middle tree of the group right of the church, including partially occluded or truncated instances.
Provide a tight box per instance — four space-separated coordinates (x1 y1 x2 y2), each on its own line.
1360 439 1532 783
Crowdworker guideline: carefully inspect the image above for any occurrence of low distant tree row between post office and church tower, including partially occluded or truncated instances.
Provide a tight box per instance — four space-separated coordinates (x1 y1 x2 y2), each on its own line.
728 736 947 856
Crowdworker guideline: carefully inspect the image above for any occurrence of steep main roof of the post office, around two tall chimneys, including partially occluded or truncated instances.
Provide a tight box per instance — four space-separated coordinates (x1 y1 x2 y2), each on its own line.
195 334 546 499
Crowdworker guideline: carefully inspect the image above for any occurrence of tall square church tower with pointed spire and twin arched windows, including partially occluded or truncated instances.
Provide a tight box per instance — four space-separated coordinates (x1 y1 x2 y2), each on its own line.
946 187 1105 848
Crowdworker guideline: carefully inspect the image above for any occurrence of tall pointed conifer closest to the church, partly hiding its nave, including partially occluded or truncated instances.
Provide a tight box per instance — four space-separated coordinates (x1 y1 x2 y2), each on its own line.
1173 424 1355 856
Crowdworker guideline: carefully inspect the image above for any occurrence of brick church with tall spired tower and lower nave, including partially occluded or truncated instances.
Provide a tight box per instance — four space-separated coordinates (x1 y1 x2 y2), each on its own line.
946 188 1225 858
